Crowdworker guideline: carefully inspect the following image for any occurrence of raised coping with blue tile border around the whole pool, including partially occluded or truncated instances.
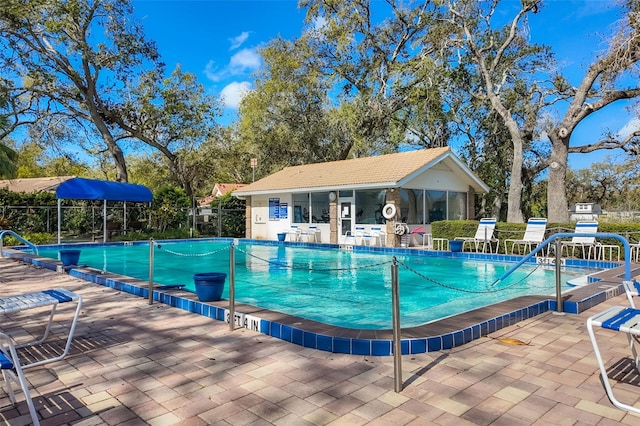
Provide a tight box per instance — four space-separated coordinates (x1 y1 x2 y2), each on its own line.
4 239 640 356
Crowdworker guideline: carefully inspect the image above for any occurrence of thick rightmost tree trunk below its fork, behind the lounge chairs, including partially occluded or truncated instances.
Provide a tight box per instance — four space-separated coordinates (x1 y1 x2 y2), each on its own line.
547 133 570 223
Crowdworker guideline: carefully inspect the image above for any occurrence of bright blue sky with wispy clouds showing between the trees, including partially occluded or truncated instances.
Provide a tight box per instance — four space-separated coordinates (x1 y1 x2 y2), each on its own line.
133 0 639 168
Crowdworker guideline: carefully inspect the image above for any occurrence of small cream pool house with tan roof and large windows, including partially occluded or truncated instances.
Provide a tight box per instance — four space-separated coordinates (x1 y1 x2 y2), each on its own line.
234 147 489 246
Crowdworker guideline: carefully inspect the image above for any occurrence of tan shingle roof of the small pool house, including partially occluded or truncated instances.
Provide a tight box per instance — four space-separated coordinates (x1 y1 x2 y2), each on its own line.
234 147 484 196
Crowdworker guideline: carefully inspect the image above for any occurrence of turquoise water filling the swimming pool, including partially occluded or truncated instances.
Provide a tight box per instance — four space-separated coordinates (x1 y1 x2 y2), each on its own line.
39 240 593 329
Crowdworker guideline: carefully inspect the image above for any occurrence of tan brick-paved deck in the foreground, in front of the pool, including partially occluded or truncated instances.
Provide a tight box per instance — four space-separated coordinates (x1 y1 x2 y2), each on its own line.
0 258 640 426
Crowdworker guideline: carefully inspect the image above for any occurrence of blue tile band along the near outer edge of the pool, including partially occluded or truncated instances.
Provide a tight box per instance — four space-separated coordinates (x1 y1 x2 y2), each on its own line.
4 245 624 356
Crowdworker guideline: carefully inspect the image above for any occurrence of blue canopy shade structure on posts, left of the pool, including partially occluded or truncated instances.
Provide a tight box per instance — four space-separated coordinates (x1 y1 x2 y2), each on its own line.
56 178 153 244
